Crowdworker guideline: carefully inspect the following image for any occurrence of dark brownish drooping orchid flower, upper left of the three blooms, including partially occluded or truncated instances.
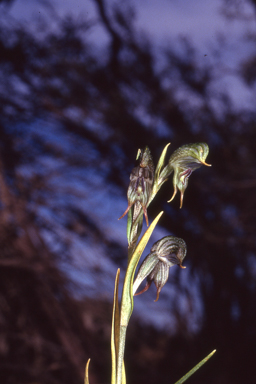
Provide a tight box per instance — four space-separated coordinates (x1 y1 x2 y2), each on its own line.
118 147 154 225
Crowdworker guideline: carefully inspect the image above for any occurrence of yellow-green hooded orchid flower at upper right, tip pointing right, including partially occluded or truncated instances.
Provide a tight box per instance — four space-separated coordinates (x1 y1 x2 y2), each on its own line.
168 143 211 208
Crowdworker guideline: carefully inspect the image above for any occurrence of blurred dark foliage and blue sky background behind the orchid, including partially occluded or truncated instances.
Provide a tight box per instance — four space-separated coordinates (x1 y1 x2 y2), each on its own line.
0 0 256 384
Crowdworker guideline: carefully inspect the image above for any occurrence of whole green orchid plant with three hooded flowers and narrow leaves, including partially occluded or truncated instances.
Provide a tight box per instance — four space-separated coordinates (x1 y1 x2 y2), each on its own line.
85 143 215 384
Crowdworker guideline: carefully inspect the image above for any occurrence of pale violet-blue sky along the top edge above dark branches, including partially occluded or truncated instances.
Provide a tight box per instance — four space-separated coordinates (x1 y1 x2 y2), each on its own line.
9 0 256 109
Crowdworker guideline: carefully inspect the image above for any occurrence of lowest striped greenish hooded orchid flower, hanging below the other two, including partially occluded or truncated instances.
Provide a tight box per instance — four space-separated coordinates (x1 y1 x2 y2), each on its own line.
133 236 187 301
